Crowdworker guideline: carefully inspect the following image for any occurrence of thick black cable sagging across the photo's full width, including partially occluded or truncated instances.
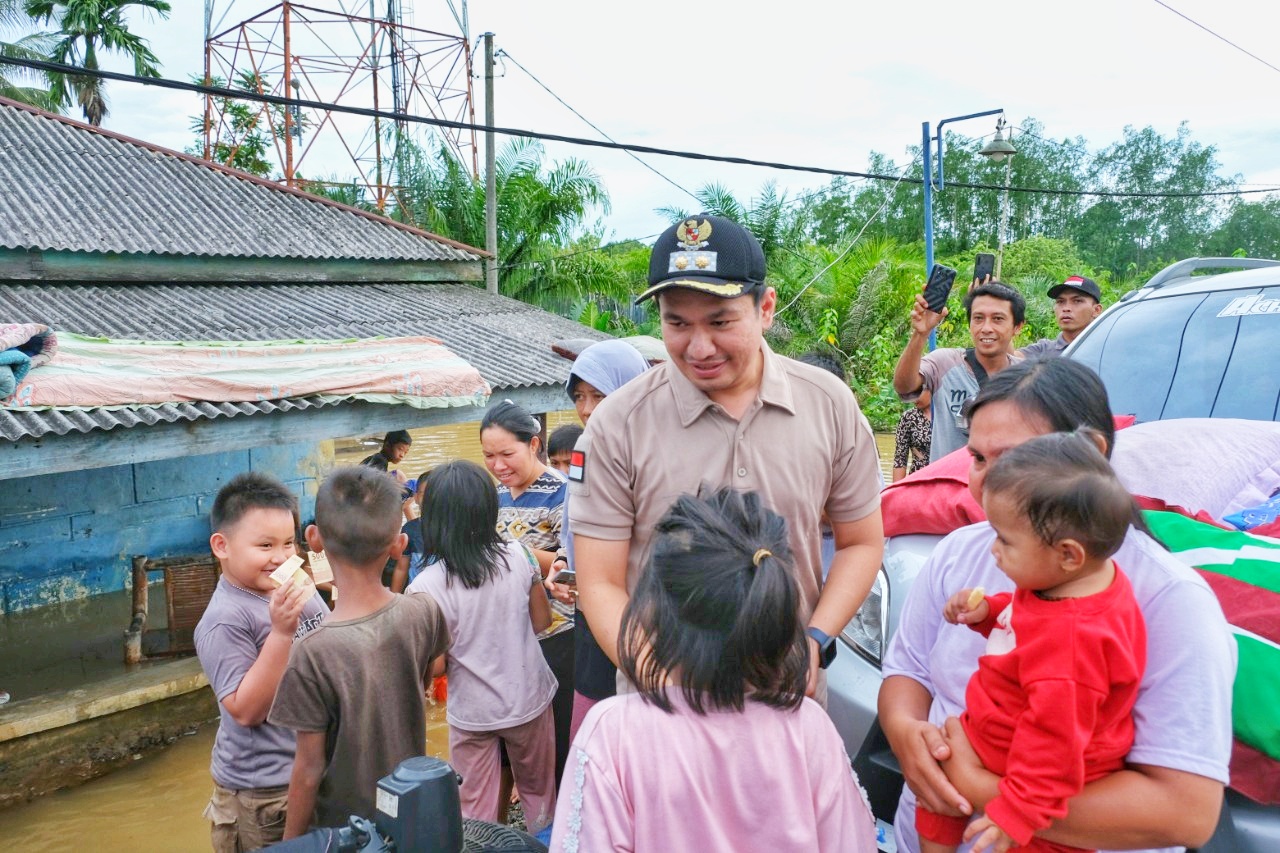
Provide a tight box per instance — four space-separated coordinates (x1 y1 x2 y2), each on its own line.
0 56 1280 199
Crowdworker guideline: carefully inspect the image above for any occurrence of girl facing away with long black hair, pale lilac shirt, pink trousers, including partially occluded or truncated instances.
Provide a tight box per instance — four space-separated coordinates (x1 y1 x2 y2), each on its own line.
408 460 557 833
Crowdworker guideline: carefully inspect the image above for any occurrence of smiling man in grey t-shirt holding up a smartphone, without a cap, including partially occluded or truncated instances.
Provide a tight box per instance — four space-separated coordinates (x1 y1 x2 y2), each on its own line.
893 280 1027 462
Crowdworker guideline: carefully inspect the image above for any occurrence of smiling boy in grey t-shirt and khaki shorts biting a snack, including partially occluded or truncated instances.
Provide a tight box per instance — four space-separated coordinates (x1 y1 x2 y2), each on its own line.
195 471 329 853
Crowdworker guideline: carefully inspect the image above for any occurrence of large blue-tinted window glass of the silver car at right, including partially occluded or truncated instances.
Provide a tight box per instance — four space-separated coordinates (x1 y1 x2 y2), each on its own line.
1071 286 1280 421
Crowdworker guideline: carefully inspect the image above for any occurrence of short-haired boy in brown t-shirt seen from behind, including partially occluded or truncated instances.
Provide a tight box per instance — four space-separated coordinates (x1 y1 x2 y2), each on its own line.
269 466 449 839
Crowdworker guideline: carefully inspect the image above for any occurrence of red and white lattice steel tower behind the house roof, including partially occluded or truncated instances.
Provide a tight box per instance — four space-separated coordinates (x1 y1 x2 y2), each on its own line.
204 0 479 211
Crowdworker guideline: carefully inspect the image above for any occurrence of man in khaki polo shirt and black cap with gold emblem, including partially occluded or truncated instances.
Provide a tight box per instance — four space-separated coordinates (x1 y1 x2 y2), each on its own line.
568 214 884 694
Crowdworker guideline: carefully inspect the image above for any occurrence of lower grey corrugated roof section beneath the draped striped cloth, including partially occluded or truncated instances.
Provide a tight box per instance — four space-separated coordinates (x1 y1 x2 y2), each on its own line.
0 282 608 441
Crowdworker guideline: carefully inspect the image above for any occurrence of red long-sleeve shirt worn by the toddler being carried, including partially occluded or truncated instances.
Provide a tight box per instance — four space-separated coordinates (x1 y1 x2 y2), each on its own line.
961 567 1147 844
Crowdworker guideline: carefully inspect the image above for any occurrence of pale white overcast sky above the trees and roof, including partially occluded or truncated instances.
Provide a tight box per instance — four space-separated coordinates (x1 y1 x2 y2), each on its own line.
92 0 1280 238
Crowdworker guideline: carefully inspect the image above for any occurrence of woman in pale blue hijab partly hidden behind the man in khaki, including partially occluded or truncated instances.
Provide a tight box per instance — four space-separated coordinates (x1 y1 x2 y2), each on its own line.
547 341 649 740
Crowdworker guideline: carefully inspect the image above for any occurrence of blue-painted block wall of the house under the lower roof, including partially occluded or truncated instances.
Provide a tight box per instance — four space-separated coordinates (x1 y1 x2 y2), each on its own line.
0 442 333 612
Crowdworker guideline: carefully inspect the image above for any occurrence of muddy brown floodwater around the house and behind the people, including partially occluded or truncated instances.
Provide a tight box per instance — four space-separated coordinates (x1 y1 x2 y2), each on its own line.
0 411 893 853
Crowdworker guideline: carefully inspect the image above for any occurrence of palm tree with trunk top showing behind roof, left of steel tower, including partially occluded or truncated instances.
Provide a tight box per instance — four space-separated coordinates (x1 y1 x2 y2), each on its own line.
26 0 169 126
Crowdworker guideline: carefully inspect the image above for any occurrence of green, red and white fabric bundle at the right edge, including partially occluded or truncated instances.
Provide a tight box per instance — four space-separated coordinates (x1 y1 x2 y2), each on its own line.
1144 511 1280 804
